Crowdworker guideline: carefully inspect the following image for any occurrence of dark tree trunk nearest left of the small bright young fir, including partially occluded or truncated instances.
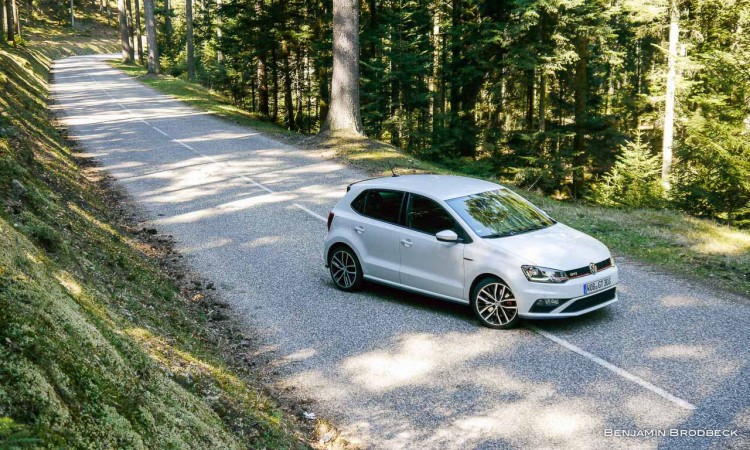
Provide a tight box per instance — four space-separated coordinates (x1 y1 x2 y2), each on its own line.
573 35 589 198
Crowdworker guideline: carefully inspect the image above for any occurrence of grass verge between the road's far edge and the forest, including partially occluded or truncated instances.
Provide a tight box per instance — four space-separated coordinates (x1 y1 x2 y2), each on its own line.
113 62 750 296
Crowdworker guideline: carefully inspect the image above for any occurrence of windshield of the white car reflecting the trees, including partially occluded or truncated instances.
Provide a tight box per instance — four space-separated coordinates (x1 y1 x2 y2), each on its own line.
447 188 556 238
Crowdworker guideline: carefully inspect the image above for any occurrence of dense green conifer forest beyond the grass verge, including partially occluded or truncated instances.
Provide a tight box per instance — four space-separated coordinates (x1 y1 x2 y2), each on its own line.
6 0 750 227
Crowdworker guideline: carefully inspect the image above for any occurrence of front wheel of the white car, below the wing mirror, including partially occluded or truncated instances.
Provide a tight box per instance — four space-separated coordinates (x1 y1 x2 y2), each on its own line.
471 277 520 330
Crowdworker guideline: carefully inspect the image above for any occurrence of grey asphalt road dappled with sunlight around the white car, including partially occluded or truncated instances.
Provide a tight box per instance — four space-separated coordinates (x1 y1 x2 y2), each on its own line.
53 56 750 449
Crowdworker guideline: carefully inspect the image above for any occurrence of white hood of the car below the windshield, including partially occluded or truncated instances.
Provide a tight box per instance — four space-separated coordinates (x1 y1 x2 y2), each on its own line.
485 223 610 270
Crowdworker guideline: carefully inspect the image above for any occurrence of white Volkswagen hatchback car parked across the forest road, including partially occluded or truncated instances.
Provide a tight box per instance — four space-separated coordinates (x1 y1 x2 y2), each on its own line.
324 175 618 328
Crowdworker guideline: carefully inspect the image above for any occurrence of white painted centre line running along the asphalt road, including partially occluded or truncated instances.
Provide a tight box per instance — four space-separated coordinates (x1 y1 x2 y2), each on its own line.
78 62 695 410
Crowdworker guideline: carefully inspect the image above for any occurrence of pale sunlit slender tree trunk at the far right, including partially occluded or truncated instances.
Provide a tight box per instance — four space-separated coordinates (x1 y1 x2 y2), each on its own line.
661 0 680 189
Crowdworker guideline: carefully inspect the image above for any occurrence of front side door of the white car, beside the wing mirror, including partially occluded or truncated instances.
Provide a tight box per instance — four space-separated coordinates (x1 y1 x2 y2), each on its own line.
399 194 468 299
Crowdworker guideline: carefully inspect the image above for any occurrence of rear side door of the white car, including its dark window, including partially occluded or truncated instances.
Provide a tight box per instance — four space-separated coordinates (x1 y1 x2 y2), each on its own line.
351 189 405 283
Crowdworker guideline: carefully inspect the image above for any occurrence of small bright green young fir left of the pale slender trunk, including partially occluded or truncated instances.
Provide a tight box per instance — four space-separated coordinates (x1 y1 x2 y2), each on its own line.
595 133 664 208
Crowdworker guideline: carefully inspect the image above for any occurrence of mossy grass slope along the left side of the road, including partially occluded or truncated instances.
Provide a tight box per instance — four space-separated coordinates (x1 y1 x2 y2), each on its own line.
0 15 308 448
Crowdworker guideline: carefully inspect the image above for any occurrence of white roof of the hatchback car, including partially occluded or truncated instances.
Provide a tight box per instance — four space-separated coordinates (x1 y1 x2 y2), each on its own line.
356 174 502 200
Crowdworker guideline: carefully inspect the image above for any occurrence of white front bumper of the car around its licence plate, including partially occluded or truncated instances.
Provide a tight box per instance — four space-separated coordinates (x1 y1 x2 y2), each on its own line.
516 266 619 319
